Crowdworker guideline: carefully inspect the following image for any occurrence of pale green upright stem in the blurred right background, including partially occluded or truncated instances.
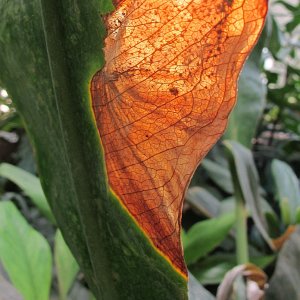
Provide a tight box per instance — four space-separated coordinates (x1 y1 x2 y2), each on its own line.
235 195 249 265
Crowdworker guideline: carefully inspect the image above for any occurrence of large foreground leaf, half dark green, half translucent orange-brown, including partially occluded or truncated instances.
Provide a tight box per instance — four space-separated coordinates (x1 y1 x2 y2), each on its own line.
0 0 267 299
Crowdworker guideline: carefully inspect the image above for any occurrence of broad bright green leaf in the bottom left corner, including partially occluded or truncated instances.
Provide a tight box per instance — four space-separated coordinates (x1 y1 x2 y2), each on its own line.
0 201 52 300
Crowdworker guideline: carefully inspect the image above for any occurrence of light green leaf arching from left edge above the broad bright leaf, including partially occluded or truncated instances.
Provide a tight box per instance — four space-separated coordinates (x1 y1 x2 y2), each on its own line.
0 163 55 223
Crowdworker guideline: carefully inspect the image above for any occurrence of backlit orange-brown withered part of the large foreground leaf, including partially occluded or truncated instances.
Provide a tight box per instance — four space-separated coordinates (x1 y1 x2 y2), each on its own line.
91 0 267 274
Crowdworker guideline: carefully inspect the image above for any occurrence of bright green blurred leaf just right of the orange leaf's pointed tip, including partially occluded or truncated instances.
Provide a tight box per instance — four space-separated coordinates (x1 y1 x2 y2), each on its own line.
183 214 235 265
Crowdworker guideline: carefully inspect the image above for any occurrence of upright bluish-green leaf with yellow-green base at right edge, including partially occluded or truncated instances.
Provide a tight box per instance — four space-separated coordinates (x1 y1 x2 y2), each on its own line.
271 159 300 225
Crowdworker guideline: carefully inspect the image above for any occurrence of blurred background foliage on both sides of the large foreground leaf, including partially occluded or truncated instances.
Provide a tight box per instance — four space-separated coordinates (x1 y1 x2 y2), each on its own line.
0 1 300 300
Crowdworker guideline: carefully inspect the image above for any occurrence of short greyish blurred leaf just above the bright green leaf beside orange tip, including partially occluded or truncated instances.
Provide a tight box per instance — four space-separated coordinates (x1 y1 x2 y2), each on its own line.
185 186 220 218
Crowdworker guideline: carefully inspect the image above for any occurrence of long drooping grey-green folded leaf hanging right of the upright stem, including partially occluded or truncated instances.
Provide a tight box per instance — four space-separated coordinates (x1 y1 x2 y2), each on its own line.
224 140 273 249
